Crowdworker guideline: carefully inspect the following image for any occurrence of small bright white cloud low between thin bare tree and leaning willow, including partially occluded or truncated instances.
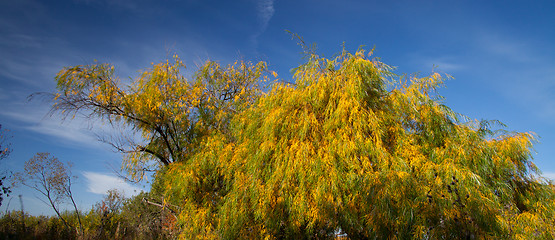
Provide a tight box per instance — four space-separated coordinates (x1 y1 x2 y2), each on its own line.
83 171 141 197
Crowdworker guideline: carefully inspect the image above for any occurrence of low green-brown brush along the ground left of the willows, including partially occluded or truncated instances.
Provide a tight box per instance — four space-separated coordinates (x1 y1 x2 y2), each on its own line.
0 190 176 239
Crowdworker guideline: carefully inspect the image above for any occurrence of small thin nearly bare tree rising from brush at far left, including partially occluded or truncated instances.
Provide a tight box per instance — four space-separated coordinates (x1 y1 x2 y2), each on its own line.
14 153 83 233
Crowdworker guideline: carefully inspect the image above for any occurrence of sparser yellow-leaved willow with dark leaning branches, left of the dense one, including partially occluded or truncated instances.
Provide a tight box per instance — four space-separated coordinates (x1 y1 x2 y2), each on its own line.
48 55 266 180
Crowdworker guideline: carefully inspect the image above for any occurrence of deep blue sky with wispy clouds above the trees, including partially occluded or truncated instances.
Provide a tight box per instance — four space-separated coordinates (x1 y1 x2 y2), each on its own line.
0 0 555 214
